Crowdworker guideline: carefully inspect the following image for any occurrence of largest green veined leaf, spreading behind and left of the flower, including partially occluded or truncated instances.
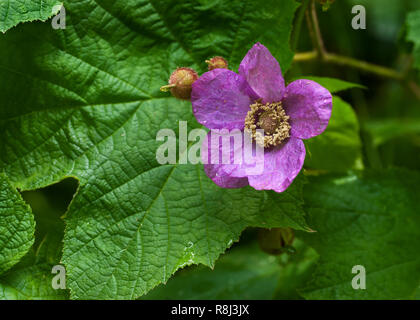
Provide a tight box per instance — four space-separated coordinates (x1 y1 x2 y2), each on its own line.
0 0 306 298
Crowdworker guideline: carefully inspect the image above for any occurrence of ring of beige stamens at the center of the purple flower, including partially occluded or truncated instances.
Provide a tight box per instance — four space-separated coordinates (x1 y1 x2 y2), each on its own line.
245 100 290 148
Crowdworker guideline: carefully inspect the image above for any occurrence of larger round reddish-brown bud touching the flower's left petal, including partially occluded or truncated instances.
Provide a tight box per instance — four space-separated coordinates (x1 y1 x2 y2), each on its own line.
160 68 198 100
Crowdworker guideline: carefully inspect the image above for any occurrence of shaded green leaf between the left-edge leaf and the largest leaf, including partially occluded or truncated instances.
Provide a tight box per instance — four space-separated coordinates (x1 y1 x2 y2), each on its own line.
0 184 69 300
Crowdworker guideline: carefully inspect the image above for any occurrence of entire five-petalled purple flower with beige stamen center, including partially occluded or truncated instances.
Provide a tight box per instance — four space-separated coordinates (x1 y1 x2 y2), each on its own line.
191 43 332 192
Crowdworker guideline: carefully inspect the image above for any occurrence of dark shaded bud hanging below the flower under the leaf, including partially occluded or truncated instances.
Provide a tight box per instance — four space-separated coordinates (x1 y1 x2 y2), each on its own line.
258 228 295 255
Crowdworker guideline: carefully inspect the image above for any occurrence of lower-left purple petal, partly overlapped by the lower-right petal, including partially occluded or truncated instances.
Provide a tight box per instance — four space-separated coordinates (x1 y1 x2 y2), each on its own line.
201 130 249 188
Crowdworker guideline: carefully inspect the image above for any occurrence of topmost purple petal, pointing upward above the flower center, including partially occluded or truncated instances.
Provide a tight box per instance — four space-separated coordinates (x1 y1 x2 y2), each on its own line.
239 42 285 103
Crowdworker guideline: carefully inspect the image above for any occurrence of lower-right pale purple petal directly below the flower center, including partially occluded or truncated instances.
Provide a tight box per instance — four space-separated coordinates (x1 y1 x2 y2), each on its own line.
248 137 306 192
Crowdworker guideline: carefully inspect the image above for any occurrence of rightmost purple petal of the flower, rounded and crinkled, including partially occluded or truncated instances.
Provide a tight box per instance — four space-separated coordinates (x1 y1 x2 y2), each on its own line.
283 80 332 139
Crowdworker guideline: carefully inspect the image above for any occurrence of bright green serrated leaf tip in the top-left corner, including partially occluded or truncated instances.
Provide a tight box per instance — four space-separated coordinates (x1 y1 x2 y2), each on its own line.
0 0 62 32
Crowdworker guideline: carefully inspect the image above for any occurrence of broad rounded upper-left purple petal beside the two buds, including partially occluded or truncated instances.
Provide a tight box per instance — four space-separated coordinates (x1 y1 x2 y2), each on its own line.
191 69 258 129
